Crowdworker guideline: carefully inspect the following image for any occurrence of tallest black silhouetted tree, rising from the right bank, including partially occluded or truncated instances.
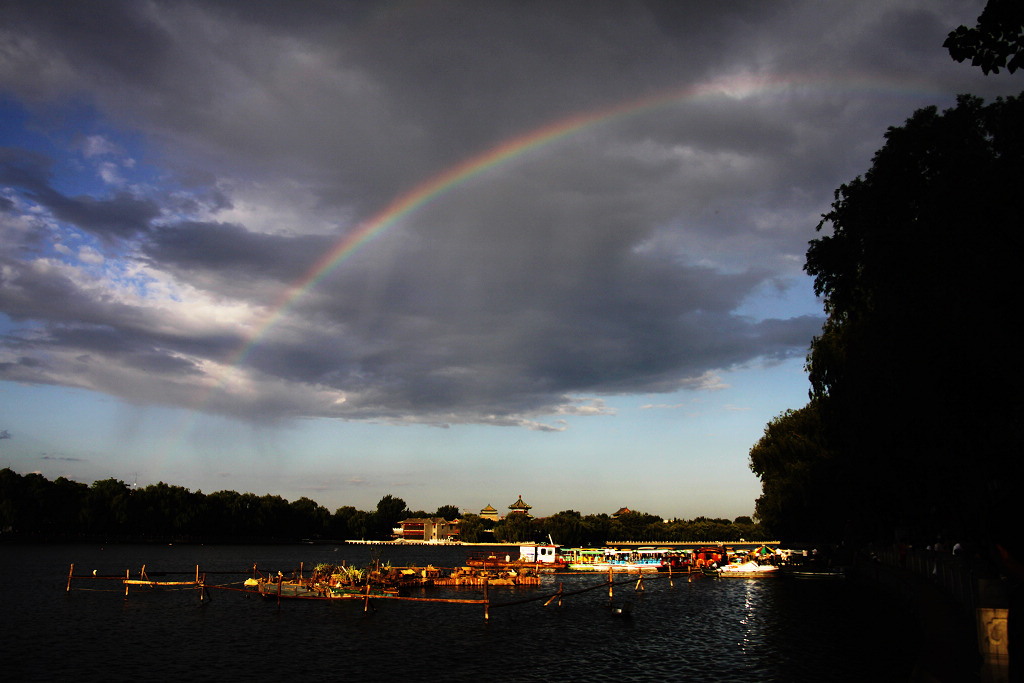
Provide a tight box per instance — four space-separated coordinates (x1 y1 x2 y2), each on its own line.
802 95 1024 538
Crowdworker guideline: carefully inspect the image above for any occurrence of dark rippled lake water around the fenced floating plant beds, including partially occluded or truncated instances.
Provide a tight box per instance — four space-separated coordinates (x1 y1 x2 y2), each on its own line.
0 545 918 683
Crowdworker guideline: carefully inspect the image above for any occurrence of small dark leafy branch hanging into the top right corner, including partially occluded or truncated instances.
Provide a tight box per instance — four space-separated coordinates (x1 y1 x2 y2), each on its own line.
942 0 1024 75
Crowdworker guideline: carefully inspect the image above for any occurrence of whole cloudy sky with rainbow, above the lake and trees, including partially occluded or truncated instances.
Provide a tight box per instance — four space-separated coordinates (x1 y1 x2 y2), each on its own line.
0 0 1022 519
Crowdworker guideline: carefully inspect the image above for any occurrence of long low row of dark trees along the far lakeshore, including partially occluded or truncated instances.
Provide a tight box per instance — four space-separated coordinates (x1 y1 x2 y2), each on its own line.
0 468 761 545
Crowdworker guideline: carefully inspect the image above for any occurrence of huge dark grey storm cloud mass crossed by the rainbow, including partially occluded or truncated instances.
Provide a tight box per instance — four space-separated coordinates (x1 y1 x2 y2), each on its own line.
0 0 996 421
